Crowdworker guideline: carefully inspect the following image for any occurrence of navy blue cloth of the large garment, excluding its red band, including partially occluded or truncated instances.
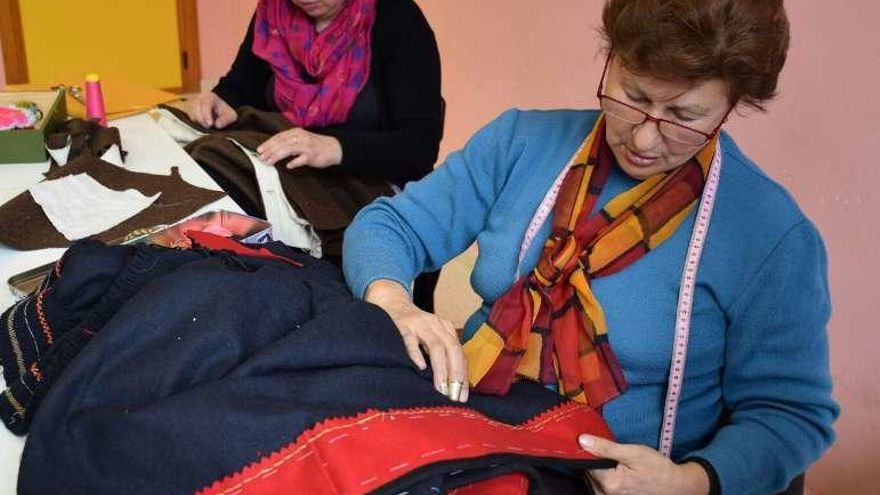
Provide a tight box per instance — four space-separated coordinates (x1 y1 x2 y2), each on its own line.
18 246 609 494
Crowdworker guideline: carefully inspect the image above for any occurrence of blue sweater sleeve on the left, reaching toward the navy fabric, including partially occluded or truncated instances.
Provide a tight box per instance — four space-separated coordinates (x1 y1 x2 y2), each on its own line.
342 110 518 297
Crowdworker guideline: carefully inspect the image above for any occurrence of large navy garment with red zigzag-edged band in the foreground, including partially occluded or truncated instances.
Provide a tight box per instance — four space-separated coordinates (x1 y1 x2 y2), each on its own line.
18 239 613 495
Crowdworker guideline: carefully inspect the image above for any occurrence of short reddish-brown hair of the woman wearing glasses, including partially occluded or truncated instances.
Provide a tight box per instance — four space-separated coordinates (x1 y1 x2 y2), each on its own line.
602 0 790 110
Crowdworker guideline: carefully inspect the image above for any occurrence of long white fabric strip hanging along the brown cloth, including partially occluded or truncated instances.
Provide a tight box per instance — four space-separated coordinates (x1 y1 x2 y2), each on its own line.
230 139 323 258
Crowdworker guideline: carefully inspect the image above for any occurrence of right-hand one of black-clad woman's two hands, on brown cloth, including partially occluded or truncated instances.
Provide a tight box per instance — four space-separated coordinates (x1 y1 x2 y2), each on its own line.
257 127 342 169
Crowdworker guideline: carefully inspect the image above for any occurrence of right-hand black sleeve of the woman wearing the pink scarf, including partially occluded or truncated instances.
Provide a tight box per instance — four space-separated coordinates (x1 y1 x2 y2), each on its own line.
313 0 443 183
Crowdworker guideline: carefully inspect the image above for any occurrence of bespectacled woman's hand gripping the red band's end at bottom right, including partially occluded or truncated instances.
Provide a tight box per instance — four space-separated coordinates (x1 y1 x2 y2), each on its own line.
578 435 709 495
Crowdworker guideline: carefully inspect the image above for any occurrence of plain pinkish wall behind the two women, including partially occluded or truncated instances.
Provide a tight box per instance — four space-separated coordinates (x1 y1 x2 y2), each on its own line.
0 0 880 495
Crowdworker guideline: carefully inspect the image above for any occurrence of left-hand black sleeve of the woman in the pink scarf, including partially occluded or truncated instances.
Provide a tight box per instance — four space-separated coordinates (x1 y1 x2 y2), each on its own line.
212 17 272 110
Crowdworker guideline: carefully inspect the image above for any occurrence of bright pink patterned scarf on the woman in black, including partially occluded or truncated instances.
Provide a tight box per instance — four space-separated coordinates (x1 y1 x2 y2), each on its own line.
253 0 376 127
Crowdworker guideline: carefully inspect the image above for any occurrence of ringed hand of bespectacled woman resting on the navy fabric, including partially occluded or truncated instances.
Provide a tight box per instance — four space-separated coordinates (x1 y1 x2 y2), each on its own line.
364 280 468 402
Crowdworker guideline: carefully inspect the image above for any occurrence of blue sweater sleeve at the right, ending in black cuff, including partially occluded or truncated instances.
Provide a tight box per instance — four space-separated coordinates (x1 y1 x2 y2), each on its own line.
685 220 839 495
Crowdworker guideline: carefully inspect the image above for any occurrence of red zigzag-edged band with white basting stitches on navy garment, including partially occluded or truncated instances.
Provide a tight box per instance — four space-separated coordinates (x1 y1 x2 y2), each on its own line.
199 402 613 495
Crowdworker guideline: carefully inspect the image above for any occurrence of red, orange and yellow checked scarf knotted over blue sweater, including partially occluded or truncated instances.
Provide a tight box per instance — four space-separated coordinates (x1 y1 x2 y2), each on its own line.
464 116 717 409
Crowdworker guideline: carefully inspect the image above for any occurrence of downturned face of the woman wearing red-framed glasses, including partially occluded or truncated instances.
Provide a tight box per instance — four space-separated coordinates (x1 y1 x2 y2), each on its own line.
604 57 730 179
